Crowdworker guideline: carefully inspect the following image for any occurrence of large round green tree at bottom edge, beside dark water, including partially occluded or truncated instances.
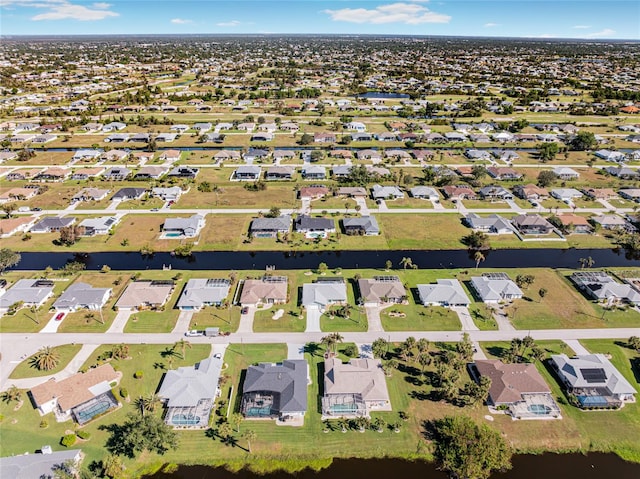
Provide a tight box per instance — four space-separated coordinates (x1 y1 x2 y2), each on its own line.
433 416 511 479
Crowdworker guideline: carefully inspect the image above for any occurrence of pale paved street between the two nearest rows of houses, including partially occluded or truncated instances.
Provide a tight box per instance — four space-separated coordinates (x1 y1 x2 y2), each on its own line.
0 328 640 390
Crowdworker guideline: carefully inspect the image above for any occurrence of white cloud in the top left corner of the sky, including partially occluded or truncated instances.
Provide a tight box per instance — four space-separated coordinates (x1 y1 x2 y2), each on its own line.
0 0 120 22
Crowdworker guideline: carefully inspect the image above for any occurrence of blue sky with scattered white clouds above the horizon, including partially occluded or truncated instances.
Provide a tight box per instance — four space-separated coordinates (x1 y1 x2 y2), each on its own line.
0 0 640 40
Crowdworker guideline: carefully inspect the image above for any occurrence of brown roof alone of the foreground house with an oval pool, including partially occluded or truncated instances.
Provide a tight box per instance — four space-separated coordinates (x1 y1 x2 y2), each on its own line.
475 359 551 405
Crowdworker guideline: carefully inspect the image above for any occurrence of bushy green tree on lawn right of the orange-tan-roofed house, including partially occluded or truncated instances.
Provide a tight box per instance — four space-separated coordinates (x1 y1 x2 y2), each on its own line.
105 413 179 458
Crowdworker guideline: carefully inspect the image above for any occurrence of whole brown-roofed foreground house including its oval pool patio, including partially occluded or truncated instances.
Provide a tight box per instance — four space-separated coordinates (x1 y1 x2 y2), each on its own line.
469 359 561 419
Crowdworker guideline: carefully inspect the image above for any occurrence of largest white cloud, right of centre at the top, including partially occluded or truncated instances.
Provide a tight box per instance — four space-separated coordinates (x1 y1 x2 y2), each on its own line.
322 2 451 25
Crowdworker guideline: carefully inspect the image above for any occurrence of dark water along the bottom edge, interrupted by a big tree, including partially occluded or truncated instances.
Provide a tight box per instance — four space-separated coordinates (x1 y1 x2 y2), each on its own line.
145 453 640 479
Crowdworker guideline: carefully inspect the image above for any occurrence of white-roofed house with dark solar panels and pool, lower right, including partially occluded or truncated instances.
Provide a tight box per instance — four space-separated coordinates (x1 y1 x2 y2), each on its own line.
551 354 637 409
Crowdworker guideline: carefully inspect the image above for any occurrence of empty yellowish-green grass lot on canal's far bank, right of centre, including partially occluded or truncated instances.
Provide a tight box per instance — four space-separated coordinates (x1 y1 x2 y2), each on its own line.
378 214 469 250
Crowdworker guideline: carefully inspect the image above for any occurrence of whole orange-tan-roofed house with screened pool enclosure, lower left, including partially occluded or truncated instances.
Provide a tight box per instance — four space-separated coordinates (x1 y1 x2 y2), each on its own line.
29 363 122 425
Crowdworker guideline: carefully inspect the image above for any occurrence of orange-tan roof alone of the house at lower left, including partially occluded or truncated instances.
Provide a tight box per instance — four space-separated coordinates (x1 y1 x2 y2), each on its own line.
31 364 118 411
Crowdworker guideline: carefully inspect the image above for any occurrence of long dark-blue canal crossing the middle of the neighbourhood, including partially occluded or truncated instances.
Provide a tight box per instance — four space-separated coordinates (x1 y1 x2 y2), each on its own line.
8 249 640 270
